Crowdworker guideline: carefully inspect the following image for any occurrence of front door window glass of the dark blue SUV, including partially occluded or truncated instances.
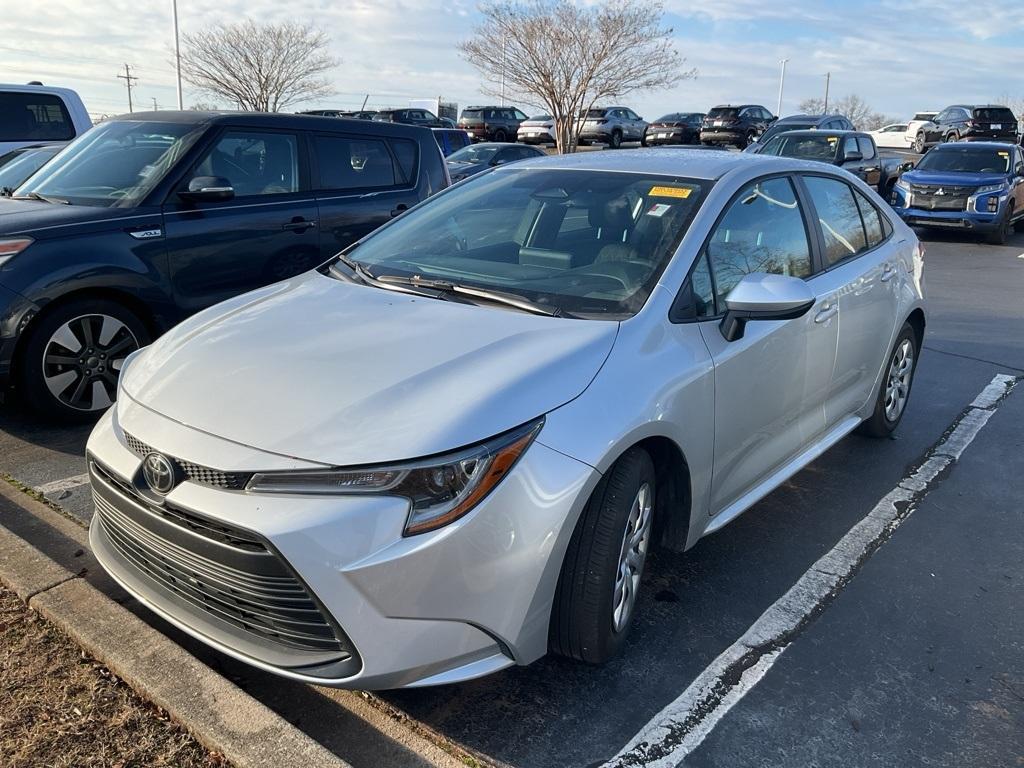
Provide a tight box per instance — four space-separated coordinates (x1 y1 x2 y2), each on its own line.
193 131 299 198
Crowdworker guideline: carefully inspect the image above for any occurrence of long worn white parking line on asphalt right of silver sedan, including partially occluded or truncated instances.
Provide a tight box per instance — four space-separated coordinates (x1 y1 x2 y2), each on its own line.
604 374 1018 768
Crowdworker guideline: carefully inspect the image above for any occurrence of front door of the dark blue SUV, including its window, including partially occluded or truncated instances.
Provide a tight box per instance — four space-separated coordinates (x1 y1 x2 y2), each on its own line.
164 127 319 312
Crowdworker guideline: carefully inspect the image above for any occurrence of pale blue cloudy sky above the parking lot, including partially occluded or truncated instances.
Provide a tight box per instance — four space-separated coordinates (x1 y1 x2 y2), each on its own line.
0 0 1024 120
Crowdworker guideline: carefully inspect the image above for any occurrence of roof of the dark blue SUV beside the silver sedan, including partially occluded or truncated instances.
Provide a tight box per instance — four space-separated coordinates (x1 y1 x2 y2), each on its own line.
102 110 423 137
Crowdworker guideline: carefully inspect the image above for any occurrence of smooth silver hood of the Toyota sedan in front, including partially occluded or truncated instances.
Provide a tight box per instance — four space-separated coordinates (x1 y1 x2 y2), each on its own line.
122 271 618 473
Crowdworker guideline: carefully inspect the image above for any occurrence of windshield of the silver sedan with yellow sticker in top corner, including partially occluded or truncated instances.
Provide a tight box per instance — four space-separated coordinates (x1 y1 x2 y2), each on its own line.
335 168 708 318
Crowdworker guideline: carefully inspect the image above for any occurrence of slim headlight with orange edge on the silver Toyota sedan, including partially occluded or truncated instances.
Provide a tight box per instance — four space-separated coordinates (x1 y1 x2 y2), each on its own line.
246 418 544 536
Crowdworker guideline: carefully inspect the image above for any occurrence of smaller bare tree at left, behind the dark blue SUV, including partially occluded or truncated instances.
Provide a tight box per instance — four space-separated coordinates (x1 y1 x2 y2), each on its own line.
181 20 338 112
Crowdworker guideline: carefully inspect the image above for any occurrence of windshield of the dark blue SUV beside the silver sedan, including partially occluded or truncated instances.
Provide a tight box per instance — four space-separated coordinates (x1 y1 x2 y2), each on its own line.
14 120 203 208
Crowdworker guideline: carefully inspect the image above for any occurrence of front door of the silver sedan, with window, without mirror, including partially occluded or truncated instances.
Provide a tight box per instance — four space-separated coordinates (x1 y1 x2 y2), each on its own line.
693 176 839 514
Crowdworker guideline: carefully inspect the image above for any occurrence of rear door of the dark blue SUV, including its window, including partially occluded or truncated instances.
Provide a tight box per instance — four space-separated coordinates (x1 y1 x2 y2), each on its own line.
312 132 419 259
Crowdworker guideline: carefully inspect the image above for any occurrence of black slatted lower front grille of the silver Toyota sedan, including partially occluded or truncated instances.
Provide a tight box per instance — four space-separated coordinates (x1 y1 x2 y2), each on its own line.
91 462 351 660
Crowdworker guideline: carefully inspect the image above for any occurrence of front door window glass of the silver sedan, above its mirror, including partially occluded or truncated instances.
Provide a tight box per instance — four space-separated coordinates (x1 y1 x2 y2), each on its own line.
694 178 811 312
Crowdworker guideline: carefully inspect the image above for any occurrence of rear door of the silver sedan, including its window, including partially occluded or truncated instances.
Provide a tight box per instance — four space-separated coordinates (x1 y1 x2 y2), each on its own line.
802 175 908 427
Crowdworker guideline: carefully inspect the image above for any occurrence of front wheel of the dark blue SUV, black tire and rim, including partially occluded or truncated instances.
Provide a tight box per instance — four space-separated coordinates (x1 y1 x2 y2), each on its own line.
14 299 150 421
